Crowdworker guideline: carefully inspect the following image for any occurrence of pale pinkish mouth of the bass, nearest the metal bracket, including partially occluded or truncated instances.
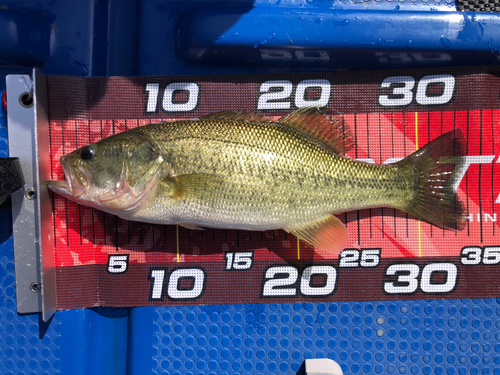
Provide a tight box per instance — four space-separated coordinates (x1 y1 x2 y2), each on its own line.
48 156 92 198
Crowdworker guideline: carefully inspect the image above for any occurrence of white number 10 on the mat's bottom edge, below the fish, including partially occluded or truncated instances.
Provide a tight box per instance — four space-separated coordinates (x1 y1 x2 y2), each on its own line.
149 268 205 301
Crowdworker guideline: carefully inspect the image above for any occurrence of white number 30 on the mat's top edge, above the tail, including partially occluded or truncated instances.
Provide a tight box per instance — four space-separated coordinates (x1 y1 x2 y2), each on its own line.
378 74 455 107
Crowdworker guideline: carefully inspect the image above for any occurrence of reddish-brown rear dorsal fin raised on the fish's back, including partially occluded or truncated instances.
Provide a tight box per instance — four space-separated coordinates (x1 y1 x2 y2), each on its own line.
276 106 354 155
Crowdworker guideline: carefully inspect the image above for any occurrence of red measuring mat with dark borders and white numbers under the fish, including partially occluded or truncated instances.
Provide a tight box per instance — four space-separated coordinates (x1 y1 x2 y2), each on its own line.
47 68 500 309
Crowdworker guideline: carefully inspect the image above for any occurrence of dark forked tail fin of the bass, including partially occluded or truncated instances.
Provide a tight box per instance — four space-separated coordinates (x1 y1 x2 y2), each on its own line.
397 129 465 230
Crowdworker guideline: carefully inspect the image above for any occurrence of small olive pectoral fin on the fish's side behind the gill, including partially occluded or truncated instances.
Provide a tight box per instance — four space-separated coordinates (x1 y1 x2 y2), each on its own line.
164 173 224 200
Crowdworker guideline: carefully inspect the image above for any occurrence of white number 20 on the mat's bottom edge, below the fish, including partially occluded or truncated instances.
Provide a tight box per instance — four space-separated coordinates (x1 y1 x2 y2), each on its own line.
261 265 337 297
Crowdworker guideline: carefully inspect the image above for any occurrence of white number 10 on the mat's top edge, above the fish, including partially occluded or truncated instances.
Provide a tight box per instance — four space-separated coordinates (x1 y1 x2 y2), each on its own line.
145 82 200 113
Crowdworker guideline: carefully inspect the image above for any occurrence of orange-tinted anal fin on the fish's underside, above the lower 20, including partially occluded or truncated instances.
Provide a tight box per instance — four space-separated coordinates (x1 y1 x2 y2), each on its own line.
285 215 348 253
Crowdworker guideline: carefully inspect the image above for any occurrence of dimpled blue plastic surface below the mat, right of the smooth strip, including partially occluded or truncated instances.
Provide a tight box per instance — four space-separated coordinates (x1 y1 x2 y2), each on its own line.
153 299 500 375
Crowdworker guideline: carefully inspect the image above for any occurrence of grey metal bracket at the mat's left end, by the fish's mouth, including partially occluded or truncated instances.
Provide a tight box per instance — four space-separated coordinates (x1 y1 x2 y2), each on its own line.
6 69 56 321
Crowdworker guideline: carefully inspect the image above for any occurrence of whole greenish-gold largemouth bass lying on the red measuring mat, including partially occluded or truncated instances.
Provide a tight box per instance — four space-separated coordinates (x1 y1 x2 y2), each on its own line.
48 107 464 252
